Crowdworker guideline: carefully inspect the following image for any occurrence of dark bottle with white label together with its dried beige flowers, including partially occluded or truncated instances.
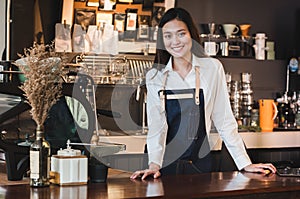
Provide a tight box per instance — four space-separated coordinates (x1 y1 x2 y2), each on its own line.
16 43 63 187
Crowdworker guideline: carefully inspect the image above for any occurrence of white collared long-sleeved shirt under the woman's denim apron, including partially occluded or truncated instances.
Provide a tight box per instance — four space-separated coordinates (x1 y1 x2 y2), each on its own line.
146 55 251 169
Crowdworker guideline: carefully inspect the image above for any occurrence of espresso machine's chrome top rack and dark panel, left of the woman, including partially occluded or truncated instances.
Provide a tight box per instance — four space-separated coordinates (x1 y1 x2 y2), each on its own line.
65 54 154 135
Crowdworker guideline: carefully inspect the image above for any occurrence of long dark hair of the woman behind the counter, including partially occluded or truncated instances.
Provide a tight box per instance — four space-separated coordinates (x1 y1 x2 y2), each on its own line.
153 8 205 70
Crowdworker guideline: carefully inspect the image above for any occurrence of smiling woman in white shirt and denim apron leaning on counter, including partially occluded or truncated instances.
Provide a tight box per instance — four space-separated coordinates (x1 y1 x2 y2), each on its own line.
131 8 276 179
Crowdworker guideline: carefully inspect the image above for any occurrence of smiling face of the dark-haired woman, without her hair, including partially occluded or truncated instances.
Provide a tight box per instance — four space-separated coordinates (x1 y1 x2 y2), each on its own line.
162 19 192 60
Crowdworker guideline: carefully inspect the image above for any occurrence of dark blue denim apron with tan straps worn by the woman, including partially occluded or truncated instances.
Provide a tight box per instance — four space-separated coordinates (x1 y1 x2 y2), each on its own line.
159 66 211 175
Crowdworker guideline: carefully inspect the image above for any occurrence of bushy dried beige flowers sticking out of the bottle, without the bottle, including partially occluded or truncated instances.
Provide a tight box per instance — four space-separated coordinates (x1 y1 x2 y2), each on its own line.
16 43 63 127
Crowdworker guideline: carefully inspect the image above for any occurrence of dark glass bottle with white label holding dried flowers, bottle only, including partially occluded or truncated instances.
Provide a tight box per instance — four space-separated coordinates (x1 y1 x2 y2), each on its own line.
29 125 50 187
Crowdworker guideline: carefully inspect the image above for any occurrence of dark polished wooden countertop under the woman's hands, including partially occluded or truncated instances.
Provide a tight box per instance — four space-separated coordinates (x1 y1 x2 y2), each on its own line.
0 169 300 199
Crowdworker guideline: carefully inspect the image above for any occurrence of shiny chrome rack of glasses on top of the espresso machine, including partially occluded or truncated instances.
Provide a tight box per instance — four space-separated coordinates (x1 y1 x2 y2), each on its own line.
72 54 154 84
